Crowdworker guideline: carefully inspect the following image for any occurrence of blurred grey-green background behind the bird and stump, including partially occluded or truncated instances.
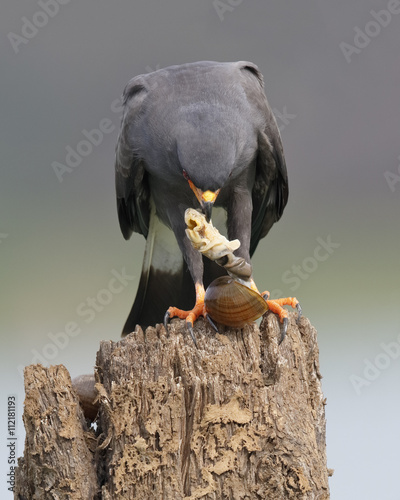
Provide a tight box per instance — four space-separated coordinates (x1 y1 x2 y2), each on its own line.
0 0 400 500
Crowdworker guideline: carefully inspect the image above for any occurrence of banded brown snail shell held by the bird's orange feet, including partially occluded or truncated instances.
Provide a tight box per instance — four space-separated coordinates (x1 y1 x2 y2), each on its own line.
204 276 268 328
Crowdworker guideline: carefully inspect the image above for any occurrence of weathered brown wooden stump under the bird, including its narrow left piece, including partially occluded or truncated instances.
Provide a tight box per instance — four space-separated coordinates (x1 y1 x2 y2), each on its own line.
15 314 329 500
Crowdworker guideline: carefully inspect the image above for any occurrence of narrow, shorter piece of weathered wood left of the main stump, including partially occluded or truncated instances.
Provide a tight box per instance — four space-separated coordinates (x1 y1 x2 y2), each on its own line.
14 365 98 500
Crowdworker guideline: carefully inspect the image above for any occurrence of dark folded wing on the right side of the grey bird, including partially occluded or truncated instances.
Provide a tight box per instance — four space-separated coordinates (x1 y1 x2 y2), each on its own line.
234 62 289 255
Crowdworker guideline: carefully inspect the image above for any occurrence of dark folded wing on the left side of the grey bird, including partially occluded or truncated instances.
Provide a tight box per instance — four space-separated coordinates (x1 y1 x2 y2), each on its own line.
115 76 150 240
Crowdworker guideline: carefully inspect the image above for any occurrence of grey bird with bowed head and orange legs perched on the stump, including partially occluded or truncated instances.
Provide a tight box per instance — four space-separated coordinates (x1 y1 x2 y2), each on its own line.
115 61 288 335
